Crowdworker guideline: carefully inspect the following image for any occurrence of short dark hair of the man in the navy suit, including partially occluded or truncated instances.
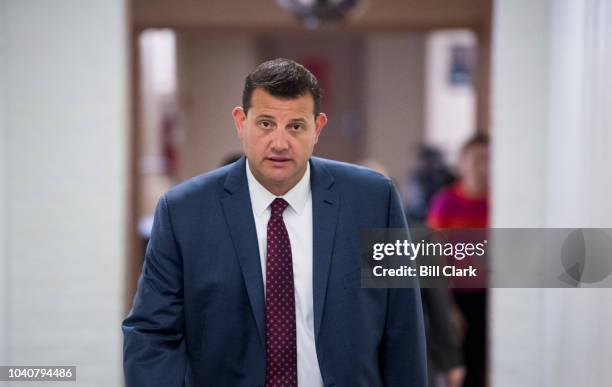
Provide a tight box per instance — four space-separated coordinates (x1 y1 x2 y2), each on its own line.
242 58 322 116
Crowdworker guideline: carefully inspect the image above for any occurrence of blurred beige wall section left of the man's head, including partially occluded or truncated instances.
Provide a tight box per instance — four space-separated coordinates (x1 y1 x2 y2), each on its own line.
177 31 257 180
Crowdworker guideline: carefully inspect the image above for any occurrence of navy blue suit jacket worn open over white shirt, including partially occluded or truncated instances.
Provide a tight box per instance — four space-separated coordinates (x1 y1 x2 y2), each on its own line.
122 157 427 387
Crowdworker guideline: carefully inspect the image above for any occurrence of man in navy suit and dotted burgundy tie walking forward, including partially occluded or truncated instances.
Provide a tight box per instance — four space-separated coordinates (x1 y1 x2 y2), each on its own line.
123 59 426 387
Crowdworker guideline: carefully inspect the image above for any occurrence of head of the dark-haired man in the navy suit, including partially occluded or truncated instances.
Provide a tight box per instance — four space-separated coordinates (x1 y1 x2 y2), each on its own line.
232 59 327 195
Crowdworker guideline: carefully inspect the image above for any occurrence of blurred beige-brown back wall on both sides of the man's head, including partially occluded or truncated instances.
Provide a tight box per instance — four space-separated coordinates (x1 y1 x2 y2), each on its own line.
171 31 425 185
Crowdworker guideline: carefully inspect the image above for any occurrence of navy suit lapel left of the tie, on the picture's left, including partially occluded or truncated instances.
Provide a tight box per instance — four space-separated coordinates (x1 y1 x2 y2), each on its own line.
221 157 266 348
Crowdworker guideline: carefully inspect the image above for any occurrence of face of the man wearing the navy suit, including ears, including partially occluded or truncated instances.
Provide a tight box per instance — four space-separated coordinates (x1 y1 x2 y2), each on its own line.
232 88 327 196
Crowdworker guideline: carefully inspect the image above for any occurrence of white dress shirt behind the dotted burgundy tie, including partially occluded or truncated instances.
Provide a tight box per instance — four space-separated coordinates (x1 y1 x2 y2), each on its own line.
246 160 323 387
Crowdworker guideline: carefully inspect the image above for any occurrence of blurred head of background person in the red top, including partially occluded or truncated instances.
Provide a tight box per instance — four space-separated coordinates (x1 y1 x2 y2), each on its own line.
459 134 489 195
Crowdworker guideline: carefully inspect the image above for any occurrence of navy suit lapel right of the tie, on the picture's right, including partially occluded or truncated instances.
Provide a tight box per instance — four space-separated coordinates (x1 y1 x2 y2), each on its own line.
310 157 340 338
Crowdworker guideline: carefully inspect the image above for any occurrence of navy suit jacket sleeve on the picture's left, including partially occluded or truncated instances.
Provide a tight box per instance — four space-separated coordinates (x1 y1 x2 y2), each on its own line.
122 196 186 387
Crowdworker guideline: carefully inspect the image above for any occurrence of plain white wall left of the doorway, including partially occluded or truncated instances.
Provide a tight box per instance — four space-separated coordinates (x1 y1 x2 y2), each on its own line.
0 0 128 386
